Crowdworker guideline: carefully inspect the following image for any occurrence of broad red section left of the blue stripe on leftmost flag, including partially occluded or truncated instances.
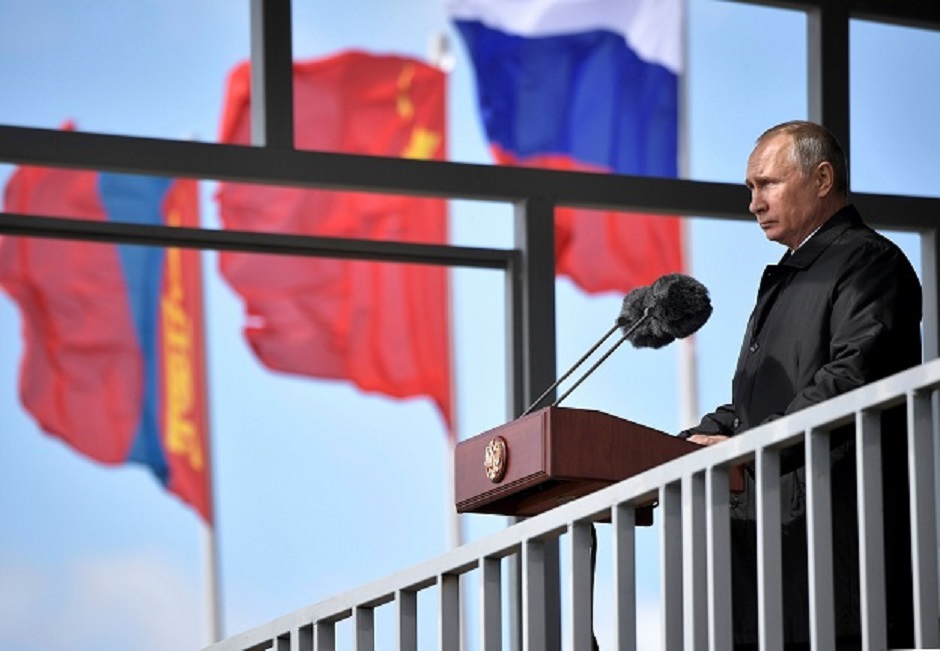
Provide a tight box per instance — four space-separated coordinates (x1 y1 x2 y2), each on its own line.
0 167 143 463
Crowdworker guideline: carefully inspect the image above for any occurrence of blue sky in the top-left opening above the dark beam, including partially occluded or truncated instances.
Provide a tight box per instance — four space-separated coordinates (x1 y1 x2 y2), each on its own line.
0 0 249 141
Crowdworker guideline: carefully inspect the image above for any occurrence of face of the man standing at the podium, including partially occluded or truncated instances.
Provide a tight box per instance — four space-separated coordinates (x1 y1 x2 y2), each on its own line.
746 134 825 249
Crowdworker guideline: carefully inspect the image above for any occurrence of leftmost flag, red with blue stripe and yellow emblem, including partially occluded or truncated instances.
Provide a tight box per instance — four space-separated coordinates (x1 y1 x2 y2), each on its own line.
0 140 212 523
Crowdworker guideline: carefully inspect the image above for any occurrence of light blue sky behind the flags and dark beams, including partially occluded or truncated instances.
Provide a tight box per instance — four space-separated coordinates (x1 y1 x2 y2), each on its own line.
0 0 940 651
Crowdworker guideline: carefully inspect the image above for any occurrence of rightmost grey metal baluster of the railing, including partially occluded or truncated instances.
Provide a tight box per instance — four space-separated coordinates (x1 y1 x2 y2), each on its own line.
907 392 940 649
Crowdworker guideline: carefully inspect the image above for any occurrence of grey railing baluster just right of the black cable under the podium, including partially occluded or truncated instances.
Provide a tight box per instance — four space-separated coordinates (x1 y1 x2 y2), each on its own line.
611 504 636 651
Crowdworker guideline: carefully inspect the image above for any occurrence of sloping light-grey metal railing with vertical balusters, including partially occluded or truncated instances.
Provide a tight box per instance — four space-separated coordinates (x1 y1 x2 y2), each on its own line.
209 360 940 651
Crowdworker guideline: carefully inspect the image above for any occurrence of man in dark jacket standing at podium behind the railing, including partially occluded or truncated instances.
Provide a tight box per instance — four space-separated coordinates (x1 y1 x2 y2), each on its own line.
681 122 921 649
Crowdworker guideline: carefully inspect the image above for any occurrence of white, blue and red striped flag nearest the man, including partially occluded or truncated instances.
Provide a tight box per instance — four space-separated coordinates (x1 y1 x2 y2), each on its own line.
448 0 684 292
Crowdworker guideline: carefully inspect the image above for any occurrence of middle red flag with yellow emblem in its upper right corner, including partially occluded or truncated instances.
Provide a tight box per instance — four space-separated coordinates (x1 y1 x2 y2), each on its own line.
218 51 452 431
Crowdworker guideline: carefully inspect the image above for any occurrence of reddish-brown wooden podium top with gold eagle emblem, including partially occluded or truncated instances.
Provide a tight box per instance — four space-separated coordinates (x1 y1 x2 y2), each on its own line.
454 407 701 524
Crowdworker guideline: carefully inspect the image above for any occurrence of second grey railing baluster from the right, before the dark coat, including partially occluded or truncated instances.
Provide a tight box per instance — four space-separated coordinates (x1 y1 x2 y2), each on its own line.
855 410 888 649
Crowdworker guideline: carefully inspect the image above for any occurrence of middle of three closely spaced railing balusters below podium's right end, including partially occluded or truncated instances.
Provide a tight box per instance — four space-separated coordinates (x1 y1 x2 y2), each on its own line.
682 473 708 649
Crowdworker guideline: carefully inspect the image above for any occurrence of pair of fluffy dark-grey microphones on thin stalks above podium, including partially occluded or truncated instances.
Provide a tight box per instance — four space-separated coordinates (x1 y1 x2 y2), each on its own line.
522 273 712 416
